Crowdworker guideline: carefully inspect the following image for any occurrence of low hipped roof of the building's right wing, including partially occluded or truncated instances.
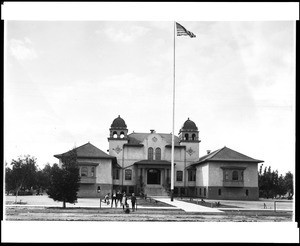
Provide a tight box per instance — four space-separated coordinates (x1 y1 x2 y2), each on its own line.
193 146 263 165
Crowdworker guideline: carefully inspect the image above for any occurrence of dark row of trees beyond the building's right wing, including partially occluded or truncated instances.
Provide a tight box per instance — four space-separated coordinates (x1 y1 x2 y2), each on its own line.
258 164 293 198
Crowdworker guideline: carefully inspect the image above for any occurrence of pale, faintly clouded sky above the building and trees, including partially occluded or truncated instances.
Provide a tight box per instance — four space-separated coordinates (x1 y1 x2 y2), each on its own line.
4 4 295 174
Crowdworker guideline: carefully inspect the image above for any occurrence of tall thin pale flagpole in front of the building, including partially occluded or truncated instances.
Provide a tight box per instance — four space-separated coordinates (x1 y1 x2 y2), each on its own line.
171 21 176 201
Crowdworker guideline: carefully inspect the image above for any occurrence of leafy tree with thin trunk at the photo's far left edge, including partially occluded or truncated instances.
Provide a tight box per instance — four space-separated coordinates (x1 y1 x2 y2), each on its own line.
5 155 37 202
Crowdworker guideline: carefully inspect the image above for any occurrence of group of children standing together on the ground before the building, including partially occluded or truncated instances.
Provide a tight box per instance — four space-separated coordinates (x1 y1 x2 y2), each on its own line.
104 191 136 213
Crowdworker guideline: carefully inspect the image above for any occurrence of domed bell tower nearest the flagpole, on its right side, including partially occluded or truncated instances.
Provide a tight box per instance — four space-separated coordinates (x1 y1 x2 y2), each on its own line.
179 118 201 161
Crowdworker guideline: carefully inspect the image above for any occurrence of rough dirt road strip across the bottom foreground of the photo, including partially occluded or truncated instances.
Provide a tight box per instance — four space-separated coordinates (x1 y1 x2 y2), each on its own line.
5 207 292 222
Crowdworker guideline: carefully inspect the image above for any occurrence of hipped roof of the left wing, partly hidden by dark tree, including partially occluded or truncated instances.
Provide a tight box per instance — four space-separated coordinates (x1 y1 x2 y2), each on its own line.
54 143 115 159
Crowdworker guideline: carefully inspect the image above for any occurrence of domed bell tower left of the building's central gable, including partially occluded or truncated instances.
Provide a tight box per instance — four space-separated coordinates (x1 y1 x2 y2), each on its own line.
108 115 128 159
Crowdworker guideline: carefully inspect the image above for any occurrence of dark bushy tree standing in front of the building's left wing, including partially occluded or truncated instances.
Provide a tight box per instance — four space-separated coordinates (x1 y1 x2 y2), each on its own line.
47 149 80 208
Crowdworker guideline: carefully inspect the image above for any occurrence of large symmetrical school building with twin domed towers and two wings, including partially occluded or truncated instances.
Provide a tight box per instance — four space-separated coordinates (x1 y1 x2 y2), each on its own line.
55 116 262 200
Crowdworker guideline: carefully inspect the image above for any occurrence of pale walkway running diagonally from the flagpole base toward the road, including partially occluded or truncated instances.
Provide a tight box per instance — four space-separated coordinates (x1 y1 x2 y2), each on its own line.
151 197 223 213
